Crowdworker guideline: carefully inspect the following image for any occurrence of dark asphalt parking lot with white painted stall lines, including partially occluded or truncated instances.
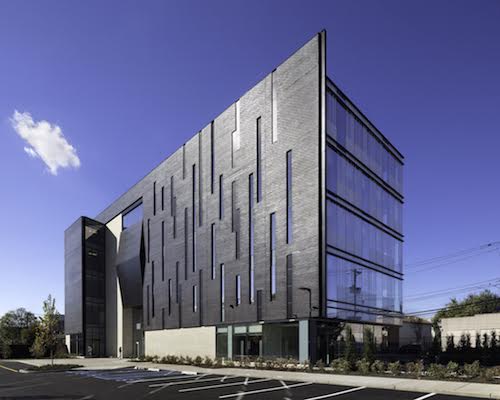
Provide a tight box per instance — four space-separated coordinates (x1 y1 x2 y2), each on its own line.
0 362 490 400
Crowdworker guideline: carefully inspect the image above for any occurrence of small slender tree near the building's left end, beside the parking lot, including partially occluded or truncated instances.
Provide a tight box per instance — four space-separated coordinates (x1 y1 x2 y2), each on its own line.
31 294 60 365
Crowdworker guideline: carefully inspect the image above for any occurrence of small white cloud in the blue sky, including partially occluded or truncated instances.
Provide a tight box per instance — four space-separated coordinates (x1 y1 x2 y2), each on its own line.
10 110 80 175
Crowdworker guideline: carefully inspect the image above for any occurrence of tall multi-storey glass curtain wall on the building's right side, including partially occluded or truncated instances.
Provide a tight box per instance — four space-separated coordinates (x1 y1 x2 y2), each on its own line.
326 88 403 323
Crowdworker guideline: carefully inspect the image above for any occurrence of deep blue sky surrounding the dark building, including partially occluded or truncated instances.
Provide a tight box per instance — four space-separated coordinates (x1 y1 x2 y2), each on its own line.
0 0 500 314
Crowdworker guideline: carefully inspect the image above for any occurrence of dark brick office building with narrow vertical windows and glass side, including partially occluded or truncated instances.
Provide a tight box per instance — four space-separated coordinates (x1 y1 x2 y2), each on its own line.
65 32 403 360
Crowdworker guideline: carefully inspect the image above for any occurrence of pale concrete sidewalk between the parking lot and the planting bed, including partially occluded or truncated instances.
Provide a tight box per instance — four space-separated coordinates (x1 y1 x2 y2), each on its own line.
13 358 500 399
